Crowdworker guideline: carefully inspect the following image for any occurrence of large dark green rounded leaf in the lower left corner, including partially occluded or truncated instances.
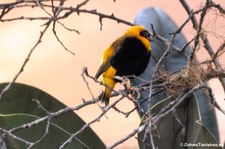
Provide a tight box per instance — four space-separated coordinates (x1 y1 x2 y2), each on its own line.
0 83 105 149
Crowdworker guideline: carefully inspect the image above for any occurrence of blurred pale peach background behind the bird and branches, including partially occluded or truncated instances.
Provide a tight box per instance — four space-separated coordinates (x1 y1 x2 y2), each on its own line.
0 0 225 149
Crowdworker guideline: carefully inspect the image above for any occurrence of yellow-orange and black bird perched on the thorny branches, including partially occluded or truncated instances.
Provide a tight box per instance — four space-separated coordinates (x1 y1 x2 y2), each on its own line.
95 25 151 106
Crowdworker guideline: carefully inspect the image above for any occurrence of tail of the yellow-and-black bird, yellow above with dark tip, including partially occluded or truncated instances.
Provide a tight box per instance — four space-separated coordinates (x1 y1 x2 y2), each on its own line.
100 78 115 106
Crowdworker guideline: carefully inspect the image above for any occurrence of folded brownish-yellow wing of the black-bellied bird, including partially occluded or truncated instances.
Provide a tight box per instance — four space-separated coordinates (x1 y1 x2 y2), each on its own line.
95 36 124 79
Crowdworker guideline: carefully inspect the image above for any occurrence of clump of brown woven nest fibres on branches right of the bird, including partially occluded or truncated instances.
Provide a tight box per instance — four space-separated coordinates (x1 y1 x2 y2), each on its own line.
157 63 215 97
